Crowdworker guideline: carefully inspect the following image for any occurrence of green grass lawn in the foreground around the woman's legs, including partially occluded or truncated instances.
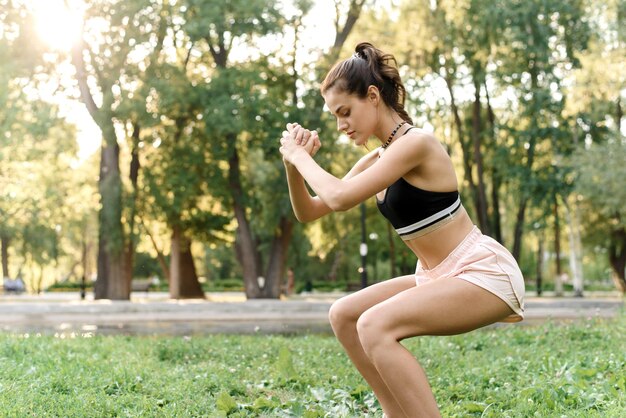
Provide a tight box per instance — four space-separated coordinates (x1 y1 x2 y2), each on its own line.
0 314 626 418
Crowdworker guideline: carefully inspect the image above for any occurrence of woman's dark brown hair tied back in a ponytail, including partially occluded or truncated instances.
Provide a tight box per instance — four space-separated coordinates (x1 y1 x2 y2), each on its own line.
320 42 413 124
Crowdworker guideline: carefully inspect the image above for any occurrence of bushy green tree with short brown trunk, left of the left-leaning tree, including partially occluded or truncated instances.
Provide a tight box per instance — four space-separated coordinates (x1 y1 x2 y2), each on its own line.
142 60 230 298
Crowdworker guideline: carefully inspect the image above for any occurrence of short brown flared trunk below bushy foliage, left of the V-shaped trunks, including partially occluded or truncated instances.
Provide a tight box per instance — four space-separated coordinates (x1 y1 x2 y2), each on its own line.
169 226 204 299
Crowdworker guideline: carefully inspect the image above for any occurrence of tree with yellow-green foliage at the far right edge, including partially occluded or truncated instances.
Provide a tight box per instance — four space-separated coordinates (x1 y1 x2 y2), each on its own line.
564 0 626 291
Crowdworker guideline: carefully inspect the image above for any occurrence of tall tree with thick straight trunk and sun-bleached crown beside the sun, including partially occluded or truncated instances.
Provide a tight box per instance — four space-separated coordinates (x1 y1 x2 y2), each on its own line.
72 0 158 299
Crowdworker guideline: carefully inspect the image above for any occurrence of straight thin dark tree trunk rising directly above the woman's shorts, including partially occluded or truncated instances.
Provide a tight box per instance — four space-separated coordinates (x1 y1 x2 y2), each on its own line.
472 80 491 235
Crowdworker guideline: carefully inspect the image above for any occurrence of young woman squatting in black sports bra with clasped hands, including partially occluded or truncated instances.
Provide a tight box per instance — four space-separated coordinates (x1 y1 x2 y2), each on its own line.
280 43 524 418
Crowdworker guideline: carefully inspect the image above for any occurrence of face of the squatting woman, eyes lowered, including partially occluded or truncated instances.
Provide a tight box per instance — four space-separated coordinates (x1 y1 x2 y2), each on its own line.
324 88 379 145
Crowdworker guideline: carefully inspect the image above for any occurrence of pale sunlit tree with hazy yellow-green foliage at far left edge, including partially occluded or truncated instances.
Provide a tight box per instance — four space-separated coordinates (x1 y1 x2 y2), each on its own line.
0 2 75 288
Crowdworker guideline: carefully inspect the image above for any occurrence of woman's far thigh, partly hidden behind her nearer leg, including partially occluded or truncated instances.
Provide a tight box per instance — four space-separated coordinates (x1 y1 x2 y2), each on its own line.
330 275 415 321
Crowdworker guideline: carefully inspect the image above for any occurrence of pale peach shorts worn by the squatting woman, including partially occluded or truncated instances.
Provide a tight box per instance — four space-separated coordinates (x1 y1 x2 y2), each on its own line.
415 226 525 322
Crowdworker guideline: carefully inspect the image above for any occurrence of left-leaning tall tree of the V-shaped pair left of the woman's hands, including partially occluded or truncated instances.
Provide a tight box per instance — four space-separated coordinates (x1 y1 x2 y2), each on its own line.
186 0 280 298
